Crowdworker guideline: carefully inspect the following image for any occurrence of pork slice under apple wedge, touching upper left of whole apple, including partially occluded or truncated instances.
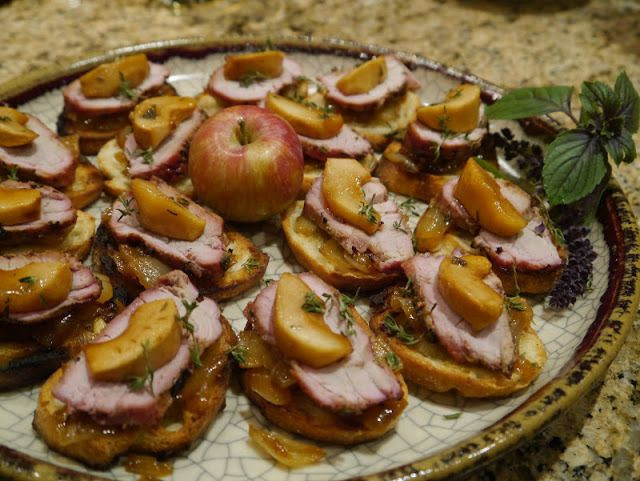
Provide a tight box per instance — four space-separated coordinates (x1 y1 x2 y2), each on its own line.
124 109 204 180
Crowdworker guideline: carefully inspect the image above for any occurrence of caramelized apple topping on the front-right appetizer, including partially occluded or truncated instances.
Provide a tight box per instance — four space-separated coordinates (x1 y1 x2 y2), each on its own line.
438 255 504 331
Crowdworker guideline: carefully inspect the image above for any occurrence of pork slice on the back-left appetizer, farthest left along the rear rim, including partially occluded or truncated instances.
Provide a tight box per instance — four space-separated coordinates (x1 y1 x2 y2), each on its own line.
62 63 169 115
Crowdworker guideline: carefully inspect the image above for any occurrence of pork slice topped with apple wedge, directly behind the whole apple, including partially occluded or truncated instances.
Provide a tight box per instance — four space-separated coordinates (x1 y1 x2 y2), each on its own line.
206 50 302 105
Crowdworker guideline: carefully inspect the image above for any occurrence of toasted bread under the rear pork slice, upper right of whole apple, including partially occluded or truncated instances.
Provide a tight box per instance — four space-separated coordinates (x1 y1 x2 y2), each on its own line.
342 90 420 150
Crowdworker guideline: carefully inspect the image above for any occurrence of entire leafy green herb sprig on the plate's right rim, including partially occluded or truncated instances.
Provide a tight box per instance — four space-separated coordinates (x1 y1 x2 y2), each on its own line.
485 72 640 210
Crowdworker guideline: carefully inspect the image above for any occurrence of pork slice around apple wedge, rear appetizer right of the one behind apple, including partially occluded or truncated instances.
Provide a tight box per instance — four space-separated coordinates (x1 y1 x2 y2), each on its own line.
319 55 420 111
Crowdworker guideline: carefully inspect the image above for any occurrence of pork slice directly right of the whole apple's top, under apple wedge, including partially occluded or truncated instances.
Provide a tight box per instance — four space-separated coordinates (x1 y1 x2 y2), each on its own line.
298 124 373 162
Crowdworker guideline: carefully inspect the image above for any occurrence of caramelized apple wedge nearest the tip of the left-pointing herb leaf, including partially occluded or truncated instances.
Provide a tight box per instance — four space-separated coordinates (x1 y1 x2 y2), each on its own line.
416 84 480 132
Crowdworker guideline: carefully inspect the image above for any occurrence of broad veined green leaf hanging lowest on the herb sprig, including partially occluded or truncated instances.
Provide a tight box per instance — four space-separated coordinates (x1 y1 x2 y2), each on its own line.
542 129 608 206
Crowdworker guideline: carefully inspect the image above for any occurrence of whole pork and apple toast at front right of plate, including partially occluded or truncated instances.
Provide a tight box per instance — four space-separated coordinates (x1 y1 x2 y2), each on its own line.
371 251 546 397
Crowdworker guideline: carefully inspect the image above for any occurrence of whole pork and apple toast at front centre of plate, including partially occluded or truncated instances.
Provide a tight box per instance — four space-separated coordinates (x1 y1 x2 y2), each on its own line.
234 273 407 444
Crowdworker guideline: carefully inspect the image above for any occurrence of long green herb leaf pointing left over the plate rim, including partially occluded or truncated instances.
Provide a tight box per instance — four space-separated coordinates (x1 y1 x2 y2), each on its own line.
484 86 573 120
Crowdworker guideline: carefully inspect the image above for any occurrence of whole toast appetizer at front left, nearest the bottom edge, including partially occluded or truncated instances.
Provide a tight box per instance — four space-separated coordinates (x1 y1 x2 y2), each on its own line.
33 271 235 469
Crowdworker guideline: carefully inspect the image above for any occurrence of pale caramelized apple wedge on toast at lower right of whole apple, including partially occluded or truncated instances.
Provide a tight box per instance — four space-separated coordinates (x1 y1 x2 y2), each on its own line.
322 158 380 234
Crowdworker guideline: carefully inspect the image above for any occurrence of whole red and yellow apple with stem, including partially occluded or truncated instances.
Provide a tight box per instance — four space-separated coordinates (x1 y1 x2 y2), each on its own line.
189 105 304 222
